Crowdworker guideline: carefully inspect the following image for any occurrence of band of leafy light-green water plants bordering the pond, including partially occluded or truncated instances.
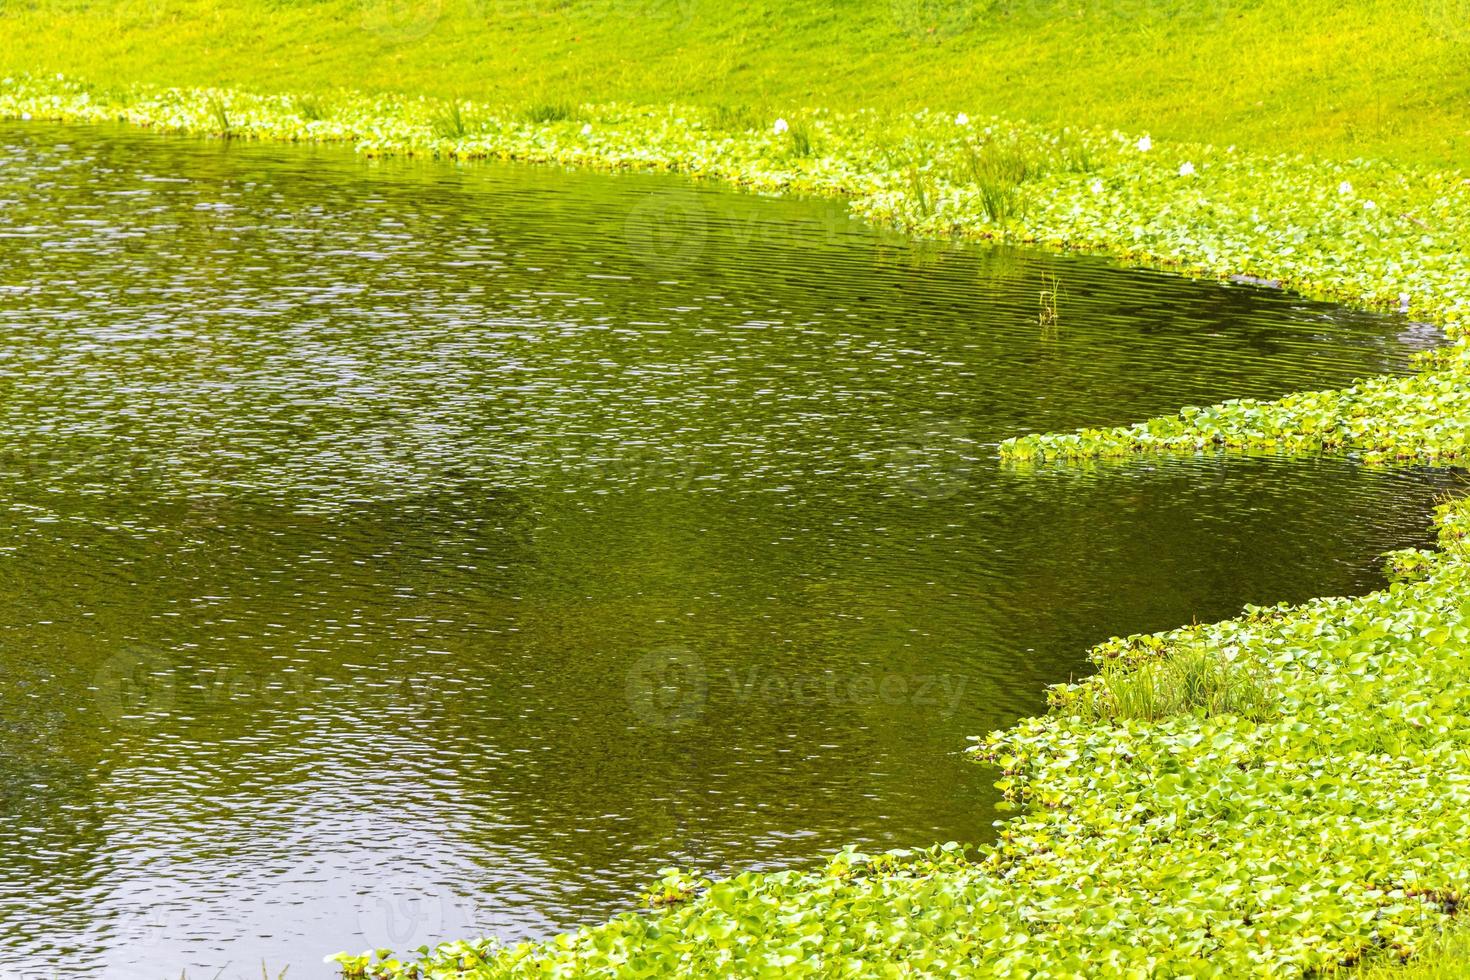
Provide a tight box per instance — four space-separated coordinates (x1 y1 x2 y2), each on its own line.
0 79 1470 977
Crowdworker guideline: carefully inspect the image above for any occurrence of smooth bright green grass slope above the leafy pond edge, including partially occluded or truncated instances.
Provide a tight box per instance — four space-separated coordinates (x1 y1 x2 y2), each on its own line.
0 0 1470 166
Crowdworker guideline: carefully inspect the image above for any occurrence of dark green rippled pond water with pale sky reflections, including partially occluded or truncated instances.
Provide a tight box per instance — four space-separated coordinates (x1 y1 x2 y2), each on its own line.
0 125 1446 977
